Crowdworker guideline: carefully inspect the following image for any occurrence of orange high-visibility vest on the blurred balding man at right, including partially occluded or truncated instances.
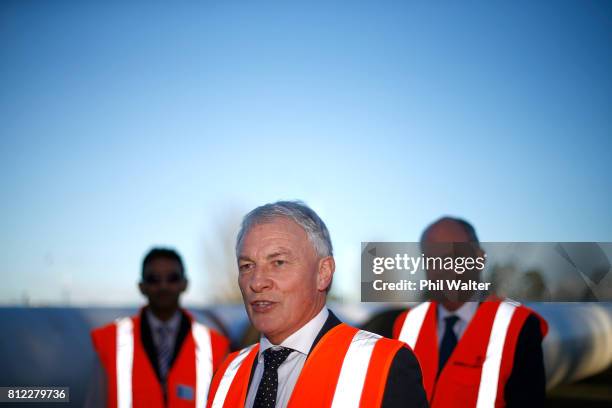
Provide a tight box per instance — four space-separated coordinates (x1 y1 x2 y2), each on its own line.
393 300 548 408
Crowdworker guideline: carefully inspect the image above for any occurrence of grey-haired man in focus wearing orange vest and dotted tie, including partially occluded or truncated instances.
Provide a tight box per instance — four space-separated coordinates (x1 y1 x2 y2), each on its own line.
209 201 427 408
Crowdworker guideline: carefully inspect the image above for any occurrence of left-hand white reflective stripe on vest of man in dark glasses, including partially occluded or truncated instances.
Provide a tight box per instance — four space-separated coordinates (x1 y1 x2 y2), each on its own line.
115 317 134 408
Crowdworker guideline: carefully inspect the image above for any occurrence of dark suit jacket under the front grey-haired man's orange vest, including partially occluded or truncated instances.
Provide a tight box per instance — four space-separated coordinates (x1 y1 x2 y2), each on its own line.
249 310 428 408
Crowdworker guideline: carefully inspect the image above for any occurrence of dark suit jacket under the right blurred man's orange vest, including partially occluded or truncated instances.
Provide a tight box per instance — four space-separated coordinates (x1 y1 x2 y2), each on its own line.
365 309 546 408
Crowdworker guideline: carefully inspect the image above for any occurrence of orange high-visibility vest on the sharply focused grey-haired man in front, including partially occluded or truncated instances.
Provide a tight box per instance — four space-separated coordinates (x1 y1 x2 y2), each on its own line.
207 323 406 408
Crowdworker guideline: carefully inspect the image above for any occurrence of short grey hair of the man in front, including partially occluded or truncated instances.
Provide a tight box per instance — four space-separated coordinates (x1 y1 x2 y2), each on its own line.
236 200 333 258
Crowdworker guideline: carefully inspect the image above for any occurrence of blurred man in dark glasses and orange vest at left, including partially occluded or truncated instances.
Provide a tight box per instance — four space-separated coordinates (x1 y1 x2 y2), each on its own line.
89 248 228 408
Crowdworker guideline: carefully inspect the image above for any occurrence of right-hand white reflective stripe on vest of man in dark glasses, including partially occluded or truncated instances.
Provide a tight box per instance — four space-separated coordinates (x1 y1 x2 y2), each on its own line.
191 321 213 408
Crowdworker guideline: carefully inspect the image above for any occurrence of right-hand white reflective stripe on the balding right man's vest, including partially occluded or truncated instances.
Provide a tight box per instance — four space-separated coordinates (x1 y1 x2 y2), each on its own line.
476 302 516 408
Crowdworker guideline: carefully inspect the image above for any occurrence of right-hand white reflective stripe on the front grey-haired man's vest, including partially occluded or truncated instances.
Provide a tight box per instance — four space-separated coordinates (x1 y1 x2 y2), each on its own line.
332 330 380 408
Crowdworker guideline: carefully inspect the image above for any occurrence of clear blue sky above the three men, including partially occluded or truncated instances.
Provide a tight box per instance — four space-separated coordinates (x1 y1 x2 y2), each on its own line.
0 0 612 304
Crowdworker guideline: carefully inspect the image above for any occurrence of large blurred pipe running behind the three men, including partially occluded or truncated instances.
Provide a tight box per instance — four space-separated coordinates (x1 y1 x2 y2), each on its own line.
0 303 612 406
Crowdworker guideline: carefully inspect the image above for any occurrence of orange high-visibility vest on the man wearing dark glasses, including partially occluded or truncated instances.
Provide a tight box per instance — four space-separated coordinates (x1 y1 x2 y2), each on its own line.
91 311 229 408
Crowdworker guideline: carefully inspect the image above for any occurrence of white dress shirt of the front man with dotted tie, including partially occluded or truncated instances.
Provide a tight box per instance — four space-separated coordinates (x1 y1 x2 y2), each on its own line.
245 307 329 408
